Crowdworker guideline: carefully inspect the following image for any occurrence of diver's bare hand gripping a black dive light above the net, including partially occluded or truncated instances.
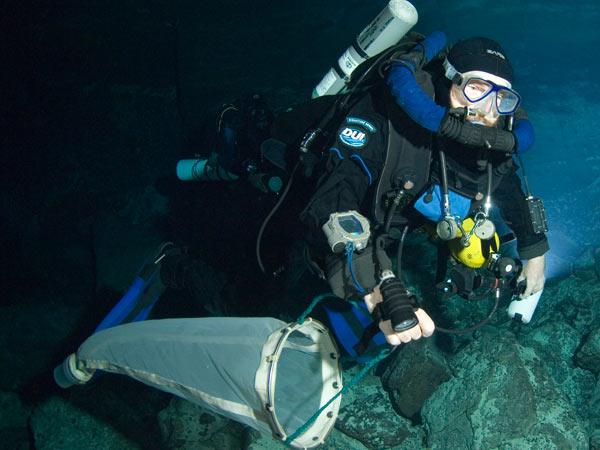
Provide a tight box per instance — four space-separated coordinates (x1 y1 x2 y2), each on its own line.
365 276 435 345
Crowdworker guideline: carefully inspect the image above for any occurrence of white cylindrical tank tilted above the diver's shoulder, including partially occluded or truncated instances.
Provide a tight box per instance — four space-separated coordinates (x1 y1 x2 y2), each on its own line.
312 0 419 98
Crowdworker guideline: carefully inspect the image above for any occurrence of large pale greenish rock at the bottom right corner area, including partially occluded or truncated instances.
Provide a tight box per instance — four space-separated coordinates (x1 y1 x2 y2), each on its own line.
422 327 588 450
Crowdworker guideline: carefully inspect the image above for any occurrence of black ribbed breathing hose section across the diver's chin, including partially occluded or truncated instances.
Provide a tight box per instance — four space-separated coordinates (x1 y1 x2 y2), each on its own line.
439 112 516 153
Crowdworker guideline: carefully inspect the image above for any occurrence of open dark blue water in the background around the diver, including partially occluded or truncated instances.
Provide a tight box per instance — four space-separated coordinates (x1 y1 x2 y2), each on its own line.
0 0 600 449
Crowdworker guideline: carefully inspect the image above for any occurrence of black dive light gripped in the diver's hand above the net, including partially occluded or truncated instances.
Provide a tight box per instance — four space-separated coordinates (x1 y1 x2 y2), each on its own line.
372 277 419 333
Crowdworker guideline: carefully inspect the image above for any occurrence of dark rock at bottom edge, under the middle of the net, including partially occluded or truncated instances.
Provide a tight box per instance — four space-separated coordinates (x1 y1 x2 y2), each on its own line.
158 398 245 450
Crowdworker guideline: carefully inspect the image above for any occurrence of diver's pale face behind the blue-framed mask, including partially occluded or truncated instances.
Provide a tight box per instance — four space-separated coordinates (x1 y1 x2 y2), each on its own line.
450 70 510 127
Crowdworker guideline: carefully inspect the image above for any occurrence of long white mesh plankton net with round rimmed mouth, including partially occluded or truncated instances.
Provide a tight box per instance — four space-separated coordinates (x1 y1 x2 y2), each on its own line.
55 317 342 448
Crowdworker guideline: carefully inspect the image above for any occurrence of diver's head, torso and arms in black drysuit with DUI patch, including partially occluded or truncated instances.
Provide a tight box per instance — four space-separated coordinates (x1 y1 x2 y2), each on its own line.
301 36 549 345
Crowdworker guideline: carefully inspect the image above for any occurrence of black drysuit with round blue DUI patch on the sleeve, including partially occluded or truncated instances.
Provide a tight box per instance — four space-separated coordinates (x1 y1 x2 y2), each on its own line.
301 81 549 296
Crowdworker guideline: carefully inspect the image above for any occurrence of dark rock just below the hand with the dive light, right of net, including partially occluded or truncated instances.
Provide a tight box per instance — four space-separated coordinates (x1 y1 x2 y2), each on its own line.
381 339 452 422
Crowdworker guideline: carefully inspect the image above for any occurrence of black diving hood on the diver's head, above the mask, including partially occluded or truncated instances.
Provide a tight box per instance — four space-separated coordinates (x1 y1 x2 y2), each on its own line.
448 37 514 84
